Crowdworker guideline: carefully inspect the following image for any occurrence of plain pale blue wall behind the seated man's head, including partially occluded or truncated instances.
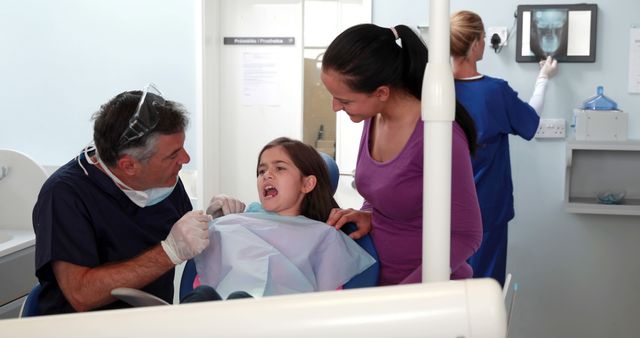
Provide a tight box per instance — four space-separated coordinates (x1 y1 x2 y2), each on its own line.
0 0 199 166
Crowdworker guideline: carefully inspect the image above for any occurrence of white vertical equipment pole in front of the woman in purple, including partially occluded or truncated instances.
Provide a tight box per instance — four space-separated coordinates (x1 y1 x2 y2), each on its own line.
422 0 455 283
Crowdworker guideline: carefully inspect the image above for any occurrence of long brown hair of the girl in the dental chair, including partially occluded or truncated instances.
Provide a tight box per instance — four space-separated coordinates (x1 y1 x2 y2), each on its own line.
256 137 338 222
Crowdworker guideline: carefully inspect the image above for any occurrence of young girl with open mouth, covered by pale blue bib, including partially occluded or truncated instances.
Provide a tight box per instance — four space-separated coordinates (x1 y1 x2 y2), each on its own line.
195 137 375 298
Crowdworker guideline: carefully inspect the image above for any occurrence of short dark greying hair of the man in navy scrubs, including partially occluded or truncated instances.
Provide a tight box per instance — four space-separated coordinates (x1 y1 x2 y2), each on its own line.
93 91 189 166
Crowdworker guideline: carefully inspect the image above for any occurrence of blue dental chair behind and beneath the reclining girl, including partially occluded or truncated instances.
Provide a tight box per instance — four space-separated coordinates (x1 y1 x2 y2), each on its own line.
179 152 380 300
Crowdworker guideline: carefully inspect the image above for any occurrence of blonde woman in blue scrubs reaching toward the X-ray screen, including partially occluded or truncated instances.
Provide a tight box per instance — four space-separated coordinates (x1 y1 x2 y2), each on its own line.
451 11 557 285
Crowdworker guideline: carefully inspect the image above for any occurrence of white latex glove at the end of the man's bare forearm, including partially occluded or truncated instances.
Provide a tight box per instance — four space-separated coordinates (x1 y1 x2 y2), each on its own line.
160 210 213 265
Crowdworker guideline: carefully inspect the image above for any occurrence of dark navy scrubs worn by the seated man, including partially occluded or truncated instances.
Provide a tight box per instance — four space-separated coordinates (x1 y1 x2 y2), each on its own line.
33 155 192 314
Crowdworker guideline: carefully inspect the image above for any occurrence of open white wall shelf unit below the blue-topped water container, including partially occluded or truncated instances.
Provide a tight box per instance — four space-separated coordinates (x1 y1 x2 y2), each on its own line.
564 140 640 216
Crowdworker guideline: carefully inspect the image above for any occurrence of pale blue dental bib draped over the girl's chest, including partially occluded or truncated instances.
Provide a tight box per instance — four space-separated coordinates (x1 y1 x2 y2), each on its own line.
195 212 375 298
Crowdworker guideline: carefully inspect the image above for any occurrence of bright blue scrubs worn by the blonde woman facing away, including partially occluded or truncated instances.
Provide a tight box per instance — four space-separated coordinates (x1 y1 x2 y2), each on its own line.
455 76 540 284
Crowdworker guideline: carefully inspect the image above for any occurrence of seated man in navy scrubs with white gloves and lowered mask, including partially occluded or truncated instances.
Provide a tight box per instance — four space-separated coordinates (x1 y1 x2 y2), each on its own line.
33 85 211 314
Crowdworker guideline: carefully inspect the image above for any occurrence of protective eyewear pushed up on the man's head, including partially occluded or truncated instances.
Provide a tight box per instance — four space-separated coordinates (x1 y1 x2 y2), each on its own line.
118 83 164 146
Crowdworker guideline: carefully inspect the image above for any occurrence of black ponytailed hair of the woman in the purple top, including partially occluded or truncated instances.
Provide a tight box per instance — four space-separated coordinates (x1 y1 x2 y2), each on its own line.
322 24 477 154
